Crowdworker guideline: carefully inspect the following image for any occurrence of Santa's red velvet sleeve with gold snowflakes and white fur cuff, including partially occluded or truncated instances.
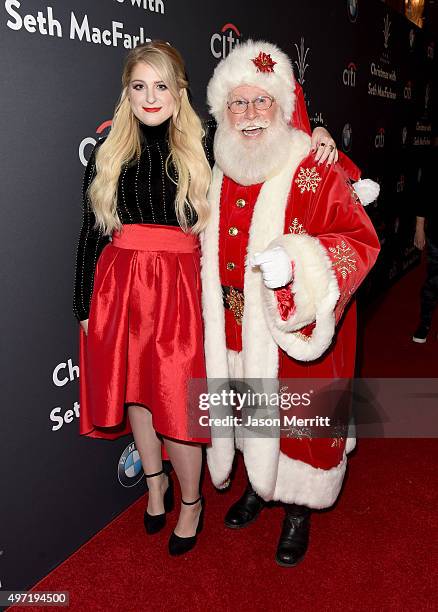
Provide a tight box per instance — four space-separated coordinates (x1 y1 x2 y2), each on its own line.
263 155 380 361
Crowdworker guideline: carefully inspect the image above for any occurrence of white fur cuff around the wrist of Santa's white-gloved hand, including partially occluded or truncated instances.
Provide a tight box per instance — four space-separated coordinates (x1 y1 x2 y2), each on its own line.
263 234 339 361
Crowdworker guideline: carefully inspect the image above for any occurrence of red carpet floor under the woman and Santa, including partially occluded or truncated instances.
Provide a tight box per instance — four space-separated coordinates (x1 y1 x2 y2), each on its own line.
18 269 438 612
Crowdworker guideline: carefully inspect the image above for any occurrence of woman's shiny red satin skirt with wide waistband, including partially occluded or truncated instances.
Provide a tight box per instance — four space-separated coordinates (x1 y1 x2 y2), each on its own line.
80 224 208 442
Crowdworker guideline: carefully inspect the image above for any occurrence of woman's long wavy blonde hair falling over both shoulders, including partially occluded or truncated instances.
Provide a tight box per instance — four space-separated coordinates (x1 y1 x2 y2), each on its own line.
88 41 211 235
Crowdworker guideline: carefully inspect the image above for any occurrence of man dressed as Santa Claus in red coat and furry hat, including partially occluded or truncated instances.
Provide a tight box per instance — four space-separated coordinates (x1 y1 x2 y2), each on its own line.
202 41 379 566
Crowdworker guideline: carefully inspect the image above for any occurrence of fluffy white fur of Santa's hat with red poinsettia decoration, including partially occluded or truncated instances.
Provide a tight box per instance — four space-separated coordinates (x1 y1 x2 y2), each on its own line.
207 40 295 122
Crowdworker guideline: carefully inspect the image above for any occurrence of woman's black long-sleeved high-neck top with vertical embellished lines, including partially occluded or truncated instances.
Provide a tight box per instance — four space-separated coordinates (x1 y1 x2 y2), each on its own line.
73 119 215 321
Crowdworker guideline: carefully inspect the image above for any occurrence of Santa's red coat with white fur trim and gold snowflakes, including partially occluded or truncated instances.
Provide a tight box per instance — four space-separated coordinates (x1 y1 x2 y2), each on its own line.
202 130 379 508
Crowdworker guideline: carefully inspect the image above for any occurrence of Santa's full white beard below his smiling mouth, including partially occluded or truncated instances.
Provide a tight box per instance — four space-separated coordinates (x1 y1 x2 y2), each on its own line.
214 119 293 185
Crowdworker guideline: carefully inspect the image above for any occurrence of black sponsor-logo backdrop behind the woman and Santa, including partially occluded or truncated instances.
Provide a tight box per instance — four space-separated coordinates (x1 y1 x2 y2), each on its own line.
0 0 436 589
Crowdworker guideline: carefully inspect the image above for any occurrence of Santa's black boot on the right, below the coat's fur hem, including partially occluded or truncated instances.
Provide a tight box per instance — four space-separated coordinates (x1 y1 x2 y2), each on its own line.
275 504 310 567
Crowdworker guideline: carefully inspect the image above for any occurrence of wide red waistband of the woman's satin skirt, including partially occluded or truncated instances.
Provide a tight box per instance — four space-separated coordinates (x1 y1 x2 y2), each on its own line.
112 223 199 253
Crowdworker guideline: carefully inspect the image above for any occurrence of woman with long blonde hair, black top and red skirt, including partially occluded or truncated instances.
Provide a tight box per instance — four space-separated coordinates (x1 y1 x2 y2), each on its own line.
74 41 210 555
